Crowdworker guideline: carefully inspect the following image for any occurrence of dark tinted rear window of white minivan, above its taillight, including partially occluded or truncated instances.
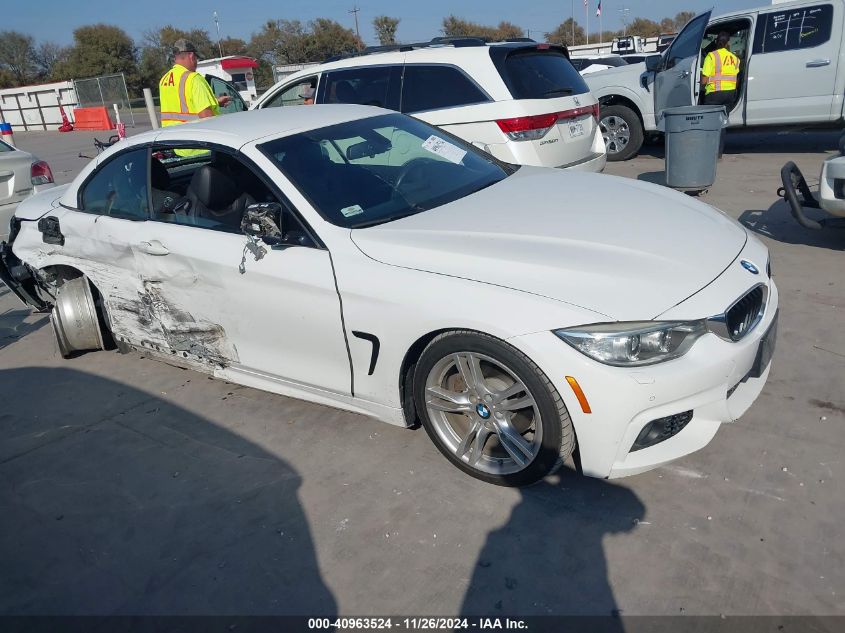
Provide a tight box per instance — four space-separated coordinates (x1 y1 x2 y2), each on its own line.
499 49 589 99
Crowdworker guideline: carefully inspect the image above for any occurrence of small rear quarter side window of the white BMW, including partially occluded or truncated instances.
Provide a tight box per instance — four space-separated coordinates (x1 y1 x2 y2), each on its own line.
80 148 149 220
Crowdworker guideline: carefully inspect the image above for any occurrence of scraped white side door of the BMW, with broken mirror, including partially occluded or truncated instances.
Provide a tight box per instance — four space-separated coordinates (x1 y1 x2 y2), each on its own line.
138 146 351 395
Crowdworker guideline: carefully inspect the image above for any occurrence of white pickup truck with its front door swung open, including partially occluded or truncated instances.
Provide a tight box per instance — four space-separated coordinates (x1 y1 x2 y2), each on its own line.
585 0 845 160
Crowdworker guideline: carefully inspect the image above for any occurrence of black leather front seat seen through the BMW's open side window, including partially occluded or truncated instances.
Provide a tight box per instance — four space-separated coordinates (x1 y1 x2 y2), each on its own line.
186 165 255 233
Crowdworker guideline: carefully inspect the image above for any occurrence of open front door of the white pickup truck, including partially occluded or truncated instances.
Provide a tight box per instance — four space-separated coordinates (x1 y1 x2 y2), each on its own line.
654 11 711 113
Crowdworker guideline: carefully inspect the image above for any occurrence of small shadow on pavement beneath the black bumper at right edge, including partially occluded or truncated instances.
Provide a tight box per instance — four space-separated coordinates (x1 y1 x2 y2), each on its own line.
739 200 845 251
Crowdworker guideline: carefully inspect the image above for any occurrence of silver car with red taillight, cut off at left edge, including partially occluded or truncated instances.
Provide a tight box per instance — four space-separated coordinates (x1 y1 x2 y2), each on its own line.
0 141 54 241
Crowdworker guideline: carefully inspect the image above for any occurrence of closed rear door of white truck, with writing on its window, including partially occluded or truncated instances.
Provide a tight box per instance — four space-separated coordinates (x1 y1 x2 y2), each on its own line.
746 2 843 125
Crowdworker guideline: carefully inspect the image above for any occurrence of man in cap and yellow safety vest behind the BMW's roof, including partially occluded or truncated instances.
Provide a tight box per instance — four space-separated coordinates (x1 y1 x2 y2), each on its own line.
158 39 229 127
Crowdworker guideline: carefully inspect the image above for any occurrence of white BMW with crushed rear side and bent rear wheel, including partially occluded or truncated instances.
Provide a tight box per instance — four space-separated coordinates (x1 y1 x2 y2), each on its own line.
0 106 778 485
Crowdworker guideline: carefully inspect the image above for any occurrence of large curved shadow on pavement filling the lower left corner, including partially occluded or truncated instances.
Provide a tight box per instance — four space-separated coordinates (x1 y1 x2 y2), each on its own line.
0 368 337 616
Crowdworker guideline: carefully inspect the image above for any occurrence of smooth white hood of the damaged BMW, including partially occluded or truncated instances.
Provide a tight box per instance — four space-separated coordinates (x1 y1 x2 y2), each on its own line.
351 167 747 321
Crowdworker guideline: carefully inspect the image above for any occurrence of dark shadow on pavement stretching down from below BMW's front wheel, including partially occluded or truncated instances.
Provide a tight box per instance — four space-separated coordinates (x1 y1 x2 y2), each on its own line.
461 471 645 631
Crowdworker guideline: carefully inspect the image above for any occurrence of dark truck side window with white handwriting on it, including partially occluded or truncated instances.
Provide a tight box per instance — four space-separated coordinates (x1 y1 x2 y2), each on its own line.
754 4 833 54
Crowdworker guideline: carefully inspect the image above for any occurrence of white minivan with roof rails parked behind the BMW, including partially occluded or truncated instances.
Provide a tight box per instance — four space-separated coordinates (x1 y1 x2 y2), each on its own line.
252 38 607 172
